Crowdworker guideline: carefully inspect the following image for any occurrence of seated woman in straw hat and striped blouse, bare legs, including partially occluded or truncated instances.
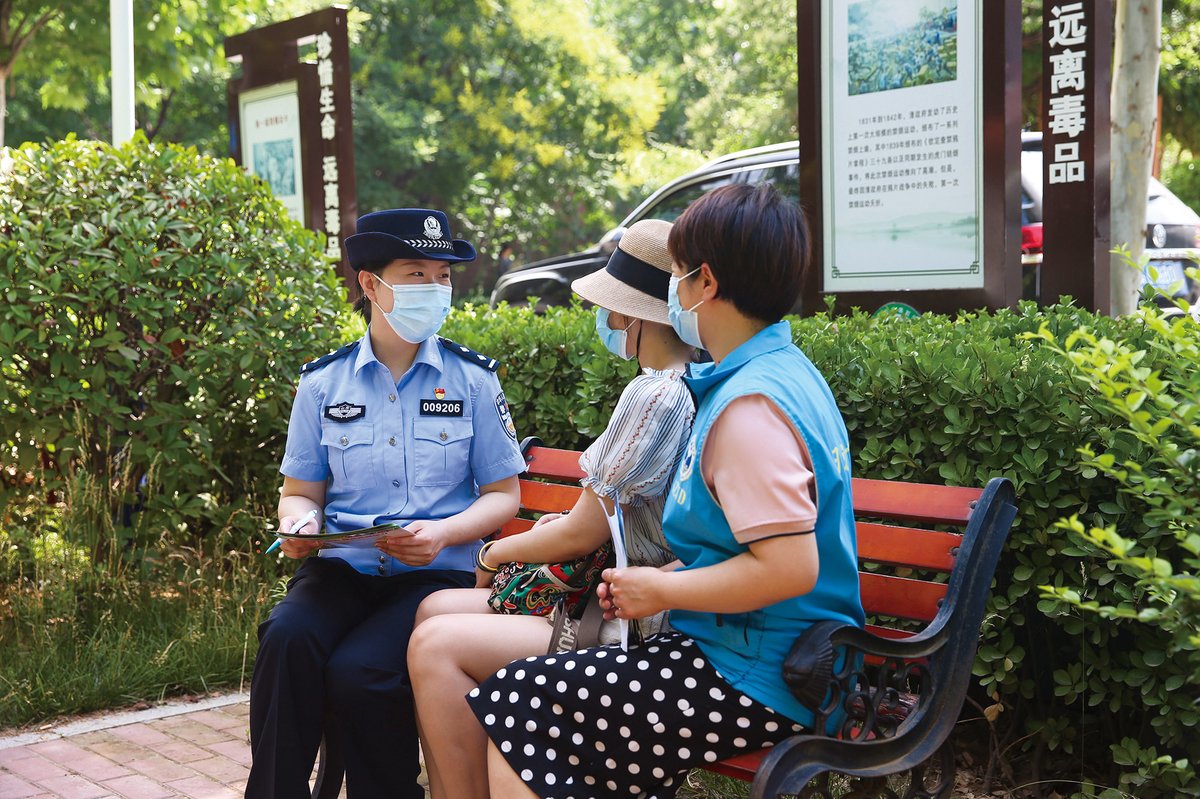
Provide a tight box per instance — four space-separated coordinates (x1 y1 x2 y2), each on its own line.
408 220 695 799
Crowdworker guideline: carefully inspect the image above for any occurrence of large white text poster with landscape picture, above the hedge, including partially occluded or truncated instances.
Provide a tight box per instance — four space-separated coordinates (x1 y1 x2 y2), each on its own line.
820 0 984 293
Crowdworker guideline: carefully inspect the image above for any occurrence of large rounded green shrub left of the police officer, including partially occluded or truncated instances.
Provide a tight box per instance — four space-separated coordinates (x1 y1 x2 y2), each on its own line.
0 137 343 554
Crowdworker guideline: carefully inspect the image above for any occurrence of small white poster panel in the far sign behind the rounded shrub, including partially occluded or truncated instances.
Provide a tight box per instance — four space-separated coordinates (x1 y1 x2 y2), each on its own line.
239 80 305 223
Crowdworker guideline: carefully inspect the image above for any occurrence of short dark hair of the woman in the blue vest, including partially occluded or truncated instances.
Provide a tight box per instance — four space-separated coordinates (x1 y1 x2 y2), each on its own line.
667 184 810 324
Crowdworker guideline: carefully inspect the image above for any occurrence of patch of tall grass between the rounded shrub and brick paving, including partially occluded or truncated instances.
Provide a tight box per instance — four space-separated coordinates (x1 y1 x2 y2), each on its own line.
0 472 280 728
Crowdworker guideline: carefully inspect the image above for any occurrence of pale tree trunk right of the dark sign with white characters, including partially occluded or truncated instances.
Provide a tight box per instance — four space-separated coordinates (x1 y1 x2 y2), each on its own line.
1110 0 1163 316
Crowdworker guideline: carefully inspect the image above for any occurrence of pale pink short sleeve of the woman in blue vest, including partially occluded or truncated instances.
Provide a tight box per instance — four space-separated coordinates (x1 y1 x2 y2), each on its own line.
700 394 817 543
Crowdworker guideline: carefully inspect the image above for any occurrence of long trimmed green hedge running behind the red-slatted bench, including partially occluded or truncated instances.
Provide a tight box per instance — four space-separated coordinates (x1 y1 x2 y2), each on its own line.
445 297 1200 797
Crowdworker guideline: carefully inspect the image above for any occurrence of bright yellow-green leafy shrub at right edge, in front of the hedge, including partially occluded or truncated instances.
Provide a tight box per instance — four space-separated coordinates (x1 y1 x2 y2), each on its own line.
1040 303 1200 797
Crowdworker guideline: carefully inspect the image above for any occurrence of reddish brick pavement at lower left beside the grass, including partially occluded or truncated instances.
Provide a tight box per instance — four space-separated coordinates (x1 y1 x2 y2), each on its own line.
0 693 346 799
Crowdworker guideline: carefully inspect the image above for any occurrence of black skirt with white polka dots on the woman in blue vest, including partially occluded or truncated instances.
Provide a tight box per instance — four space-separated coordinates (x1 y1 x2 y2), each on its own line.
467 632 800 799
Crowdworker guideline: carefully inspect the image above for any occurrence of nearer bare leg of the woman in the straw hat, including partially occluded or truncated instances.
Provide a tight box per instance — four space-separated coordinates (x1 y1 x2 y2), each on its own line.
408 611 551 799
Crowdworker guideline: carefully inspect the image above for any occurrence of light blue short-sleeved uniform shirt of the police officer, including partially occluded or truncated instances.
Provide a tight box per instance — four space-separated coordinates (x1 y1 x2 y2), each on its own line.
280 331 526 575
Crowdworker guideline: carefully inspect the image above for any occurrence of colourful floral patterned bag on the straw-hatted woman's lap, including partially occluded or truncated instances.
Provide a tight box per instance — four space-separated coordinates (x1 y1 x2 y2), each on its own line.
487 542 612 615
